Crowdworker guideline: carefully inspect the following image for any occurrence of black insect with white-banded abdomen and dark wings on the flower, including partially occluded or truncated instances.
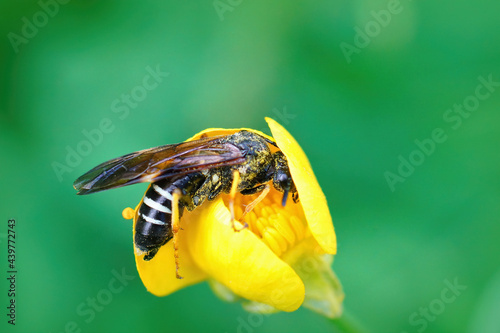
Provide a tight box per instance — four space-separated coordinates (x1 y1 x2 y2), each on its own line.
73 130 298 277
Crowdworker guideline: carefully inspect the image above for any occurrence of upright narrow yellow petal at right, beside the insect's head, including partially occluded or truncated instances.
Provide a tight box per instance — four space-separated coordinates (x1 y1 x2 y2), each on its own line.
266 118 337 254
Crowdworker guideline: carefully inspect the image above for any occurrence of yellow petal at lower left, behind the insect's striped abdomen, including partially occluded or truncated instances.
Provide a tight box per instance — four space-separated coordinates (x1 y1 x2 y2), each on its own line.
133 198 207 296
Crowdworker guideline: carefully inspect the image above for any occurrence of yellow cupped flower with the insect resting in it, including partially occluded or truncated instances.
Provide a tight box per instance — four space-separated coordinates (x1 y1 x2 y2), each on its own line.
123 118 344 318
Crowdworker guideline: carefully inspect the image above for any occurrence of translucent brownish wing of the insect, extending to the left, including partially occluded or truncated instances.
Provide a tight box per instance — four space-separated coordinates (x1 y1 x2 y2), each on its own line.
73 137 245 195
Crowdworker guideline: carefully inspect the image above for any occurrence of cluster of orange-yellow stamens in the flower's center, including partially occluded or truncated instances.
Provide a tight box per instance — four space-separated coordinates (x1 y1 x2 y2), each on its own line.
223 188 309 257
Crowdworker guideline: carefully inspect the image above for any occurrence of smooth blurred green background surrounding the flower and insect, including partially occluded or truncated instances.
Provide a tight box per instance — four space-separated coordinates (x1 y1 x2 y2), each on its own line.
0 0 500 333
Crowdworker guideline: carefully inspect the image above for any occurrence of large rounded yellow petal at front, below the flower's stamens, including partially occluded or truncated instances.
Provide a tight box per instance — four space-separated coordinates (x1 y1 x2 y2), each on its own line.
181 197 304 311
